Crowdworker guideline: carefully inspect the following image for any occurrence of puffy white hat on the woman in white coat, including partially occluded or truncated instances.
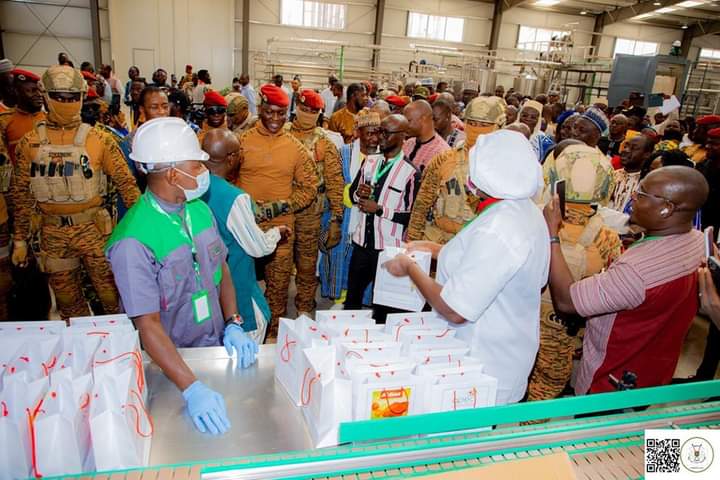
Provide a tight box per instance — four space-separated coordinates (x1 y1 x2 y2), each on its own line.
470 130 543 200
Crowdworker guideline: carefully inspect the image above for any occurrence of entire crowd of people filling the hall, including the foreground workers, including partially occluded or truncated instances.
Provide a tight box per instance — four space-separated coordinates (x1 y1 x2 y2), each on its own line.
0 53 720 433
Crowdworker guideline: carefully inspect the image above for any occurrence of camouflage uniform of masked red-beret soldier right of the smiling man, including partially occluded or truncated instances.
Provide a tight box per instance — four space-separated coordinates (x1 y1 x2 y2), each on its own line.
285 123 345 312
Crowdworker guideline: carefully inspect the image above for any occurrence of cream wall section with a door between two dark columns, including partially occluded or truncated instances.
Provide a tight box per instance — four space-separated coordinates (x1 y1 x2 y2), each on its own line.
109 0 235 87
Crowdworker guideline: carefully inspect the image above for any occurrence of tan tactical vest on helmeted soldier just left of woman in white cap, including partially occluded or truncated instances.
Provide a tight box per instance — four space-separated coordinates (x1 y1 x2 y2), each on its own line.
425 148 475 244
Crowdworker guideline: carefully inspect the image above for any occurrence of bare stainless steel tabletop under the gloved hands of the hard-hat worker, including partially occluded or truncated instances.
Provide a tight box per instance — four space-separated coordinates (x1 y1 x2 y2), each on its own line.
145 345 312 465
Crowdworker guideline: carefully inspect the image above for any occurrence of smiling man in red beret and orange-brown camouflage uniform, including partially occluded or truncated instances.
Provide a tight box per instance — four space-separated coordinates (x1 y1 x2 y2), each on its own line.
236 85 318 340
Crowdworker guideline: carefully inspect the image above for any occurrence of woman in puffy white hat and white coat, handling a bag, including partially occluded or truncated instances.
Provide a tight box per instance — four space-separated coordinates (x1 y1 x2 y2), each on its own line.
383 130 550 405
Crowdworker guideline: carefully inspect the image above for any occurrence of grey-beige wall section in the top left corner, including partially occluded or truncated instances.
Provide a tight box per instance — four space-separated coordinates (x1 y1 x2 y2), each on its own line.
0 0 111 73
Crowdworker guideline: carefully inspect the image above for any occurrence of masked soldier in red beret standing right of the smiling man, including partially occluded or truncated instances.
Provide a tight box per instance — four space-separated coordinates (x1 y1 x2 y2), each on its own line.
285 89 345 314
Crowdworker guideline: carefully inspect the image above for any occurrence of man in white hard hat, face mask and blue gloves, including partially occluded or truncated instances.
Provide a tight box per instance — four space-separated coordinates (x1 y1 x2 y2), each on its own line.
106 117 257 434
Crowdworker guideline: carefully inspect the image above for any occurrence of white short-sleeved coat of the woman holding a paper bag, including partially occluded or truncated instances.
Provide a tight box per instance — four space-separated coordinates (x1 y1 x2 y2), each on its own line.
437 199 550 405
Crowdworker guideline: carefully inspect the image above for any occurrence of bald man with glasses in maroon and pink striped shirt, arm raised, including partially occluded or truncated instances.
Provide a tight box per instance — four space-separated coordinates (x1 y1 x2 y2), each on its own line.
544 167 708 394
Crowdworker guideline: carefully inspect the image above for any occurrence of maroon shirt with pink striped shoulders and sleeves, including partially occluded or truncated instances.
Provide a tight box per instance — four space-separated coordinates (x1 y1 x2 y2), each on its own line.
570 230 704 394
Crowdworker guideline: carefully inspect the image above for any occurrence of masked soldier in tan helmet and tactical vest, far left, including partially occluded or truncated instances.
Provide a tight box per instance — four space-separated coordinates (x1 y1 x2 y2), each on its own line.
11 66 140 318
